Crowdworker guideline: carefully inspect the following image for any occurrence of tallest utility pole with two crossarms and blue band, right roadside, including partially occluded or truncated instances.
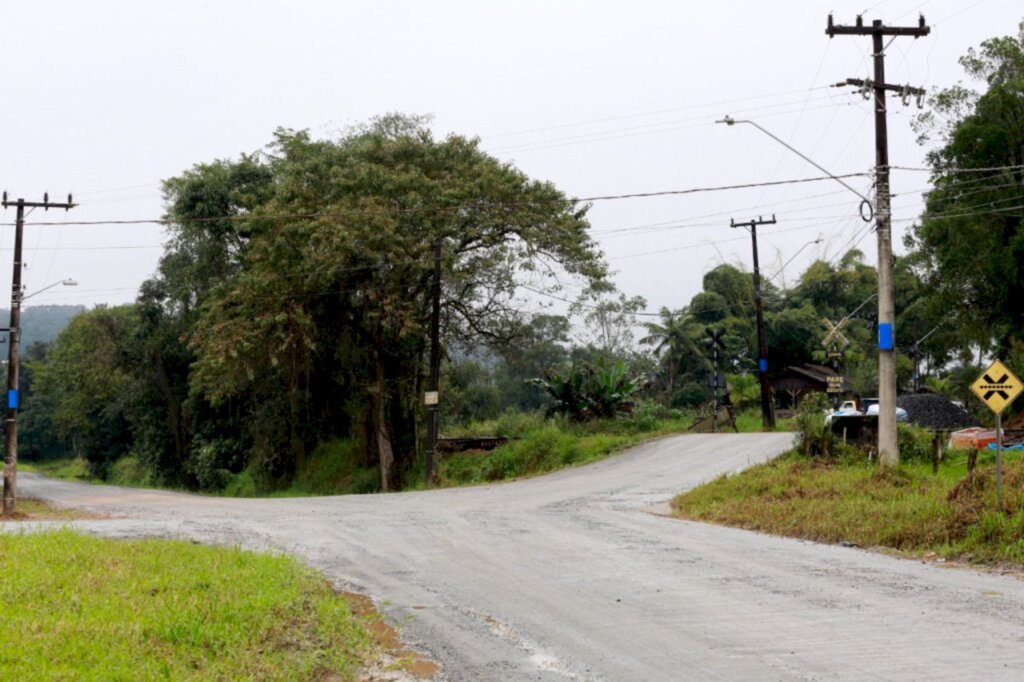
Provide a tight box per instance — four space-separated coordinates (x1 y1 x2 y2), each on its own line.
825 14 932 468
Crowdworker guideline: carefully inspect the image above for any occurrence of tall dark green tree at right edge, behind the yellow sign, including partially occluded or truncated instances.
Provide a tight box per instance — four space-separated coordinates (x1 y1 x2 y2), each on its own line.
908 25 1024 350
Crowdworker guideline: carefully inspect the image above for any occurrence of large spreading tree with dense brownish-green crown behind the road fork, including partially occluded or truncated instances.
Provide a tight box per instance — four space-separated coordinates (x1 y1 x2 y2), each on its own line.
182 116 605 489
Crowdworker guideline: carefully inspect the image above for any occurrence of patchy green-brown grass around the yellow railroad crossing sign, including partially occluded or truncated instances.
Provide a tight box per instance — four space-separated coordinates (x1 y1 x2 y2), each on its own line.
673 446 1024 563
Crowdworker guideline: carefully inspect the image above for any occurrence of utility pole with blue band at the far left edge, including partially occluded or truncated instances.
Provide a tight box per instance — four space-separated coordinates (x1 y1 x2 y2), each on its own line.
2 191 75 509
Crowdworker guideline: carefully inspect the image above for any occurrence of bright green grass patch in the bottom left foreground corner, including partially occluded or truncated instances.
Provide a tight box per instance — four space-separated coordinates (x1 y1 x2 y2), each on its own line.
0 530 373 680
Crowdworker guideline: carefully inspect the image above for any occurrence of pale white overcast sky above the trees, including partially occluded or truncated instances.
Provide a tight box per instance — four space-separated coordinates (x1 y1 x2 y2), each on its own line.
0 0 1024 310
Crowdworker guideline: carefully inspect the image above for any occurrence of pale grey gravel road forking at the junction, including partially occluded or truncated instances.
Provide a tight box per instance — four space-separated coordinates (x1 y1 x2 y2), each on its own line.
19 434 1024 682
